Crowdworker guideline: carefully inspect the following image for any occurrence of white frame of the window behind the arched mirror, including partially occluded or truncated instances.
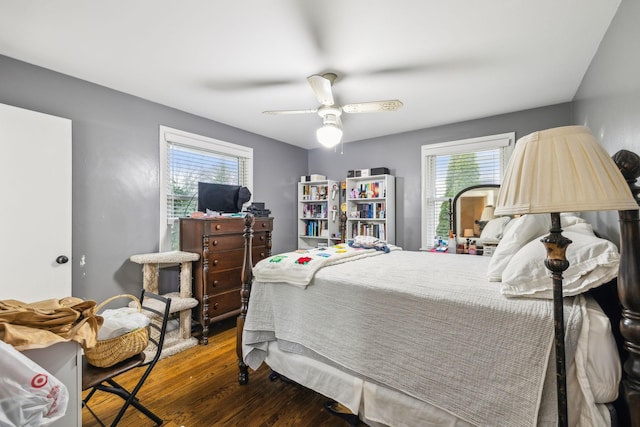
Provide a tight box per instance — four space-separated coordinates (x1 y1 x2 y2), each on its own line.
420 132 515 250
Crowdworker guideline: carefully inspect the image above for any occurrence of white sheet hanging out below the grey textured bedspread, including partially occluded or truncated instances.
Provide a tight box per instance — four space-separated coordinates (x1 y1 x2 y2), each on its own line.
265 299 621 427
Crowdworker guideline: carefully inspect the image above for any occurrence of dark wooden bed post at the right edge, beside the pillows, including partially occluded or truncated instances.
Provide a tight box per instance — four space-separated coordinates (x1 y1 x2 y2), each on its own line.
613 150 640 427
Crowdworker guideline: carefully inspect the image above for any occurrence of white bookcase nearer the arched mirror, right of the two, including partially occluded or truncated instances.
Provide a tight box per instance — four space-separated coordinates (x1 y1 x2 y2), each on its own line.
346 175 396 244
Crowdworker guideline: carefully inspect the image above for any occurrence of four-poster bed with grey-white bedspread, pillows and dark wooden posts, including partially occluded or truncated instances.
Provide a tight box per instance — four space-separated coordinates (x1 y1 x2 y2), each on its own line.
237 152 640 426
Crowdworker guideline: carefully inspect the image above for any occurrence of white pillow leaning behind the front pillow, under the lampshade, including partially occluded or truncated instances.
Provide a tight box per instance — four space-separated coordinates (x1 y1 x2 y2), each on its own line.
487 213 592 282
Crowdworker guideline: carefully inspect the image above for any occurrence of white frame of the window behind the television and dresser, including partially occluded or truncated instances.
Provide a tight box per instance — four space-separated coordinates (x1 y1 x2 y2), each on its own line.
158 126 253 252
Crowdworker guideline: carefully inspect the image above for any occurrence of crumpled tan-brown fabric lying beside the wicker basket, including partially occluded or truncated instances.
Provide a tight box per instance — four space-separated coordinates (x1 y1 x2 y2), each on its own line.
0 297 103 351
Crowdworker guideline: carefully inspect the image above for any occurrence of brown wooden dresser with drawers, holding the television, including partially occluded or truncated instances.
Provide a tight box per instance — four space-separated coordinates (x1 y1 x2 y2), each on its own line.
180 218 273 344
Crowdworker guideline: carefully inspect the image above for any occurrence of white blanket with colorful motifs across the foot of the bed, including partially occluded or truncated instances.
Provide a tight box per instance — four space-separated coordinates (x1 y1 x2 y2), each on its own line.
253 244 384 288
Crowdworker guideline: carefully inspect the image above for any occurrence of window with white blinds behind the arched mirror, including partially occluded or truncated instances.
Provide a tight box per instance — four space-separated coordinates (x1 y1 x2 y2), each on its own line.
421 132 515 250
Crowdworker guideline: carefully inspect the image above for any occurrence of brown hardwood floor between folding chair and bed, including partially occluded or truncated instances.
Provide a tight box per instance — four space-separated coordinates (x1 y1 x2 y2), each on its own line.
82 320 356 427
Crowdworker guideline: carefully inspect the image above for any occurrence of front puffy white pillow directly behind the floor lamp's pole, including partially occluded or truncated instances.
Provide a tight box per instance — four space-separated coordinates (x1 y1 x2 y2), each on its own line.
501 223 620 299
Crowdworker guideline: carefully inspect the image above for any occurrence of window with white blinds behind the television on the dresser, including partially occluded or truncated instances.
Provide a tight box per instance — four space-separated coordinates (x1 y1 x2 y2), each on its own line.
160 126 253 251
